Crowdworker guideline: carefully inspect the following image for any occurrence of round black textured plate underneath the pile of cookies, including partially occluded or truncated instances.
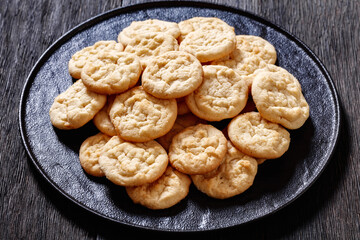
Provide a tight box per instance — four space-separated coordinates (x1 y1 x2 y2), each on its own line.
19 2 340 231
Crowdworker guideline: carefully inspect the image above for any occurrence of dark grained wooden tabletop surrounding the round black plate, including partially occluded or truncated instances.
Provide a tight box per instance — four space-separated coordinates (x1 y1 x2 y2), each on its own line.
0 0 360 239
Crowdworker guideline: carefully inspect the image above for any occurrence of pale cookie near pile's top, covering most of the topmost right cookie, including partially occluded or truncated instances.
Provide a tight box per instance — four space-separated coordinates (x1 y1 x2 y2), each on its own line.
179 25 236 63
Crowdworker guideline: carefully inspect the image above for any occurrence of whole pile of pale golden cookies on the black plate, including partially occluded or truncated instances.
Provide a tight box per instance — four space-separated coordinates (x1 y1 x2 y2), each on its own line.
50 17 309 209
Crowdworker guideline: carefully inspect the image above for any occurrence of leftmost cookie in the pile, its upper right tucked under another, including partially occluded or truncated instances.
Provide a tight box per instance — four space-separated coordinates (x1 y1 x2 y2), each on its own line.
49 80 106 129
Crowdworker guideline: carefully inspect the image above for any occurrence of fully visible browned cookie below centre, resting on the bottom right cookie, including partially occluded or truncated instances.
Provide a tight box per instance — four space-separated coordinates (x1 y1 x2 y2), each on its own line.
169 124 227 174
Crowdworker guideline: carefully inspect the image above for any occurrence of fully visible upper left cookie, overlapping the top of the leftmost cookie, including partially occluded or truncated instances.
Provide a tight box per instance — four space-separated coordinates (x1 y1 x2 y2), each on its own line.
81 51 142 94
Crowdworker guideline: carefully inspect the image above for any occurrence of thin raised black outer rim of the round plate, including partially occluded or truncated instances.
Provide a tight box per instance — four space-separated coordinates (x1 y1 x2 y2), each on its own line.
18 1 342 232
